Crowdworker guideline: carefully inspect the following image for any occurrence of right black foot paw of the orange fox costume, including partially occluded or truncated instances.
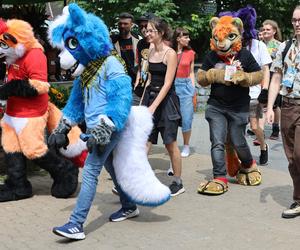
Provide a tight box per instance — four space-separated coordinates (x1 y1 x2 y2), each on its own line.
51 167 79 198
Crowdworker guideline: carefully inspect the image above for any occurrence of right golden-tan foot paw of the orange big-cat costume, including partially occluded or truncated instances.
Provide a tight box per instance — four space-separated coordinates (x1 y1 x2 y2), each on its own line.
236 164 262 186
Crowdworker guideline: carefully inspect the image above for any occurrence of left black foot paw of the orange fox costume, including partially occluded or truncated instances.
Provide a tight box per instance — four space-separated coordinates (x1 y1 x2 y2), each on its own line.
0 182 33 202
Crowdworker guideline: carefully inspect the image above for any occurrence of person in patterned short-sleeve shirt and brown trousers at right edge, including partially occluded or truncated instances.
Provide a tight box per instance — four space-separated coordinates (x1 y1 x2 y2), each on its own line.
267 5 300 218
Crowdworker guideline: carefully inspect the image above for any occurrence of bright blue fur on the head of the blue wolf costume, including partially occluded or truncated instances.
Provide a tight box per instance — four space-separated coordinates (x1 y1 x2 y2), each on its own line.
52 3 113 61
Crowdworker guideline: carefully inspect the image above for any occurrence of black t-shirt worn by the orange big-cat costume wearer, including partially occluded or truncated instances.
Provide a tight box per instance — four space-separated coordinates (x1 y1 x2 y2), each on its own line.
201 48 261 111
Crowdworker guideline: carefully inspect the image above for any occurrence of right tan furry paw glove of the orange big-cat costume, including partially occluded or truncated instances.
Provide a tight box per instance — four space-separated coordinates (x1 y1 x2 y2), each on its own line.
232 70 263 88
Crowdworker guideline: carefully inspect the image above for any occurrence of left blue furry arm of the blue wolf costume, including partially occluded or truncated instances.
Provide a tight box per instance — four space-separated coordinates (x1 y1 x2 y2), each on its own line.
62 78 84 124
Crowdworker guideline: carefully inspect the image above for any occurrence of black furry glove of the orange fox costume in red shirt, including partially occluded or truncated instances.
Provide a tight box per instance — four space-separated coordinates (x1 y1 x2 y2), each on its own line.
0 80 39 100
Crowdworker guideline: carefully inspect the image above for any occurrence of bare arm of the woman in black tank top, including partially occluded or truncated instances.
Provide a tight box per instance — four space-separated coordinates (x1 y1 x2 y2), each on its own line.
149 50 177 114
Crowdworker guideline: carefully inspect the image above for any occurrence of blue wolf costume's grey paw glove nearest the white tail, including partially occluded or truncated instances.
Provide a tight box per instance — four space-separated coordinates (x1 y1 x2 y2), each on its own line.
86 119 115 153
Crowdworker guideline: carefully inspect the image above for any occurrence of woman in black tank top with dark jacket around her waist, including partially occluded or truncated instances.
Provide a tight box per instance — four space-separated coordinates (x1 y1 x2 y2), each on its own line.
142 18 185 196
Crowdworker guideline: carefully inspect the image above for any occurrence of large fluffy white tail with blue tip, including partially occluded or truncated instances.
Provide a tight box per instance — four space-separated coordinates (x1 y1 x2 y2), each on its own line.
113 106 170 206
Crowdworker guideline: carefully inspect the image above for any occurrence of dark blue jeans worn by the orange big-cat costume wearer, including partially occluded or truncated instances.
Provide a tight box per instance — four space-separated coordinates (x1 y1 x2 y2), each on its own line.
205 105 253 178
